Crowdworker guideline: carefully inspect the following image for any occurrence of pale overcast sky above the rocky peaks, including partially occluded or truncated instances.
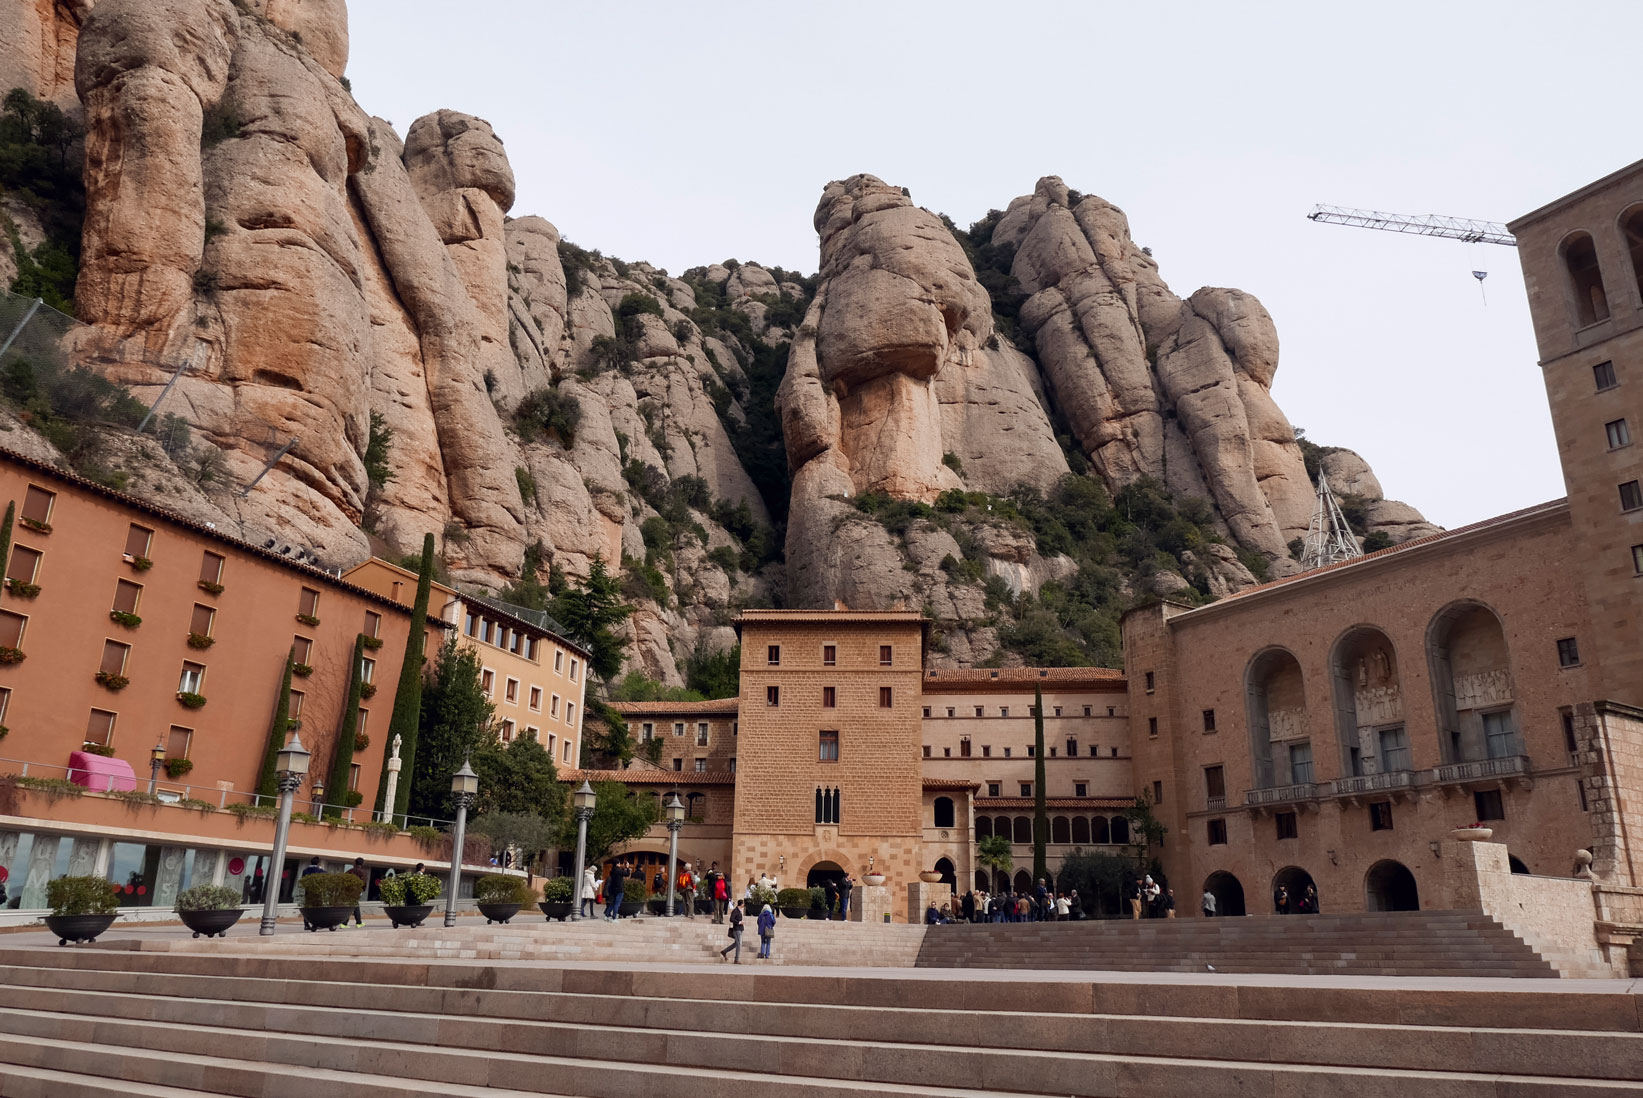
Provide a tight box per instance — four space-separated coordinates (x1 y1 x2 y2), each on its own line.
348 0 1643 528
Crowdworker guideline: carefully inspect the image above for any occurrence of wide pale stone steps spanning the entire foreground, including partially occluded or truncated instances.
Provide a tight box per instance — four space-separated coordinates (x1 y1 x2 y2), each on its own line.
0 935 1643 1098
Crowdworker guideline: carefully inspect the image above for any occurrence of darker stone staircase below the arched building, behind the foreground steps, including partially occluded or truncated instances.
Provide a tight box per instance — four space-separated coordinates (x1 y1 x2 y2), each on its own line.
918 911 1558 976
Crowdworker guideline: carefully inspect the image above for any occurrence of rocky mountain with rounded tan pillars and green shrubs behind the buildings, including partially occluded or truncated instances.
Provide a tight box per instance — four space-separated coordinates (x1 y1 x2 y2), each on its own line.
0 0 1431 682
